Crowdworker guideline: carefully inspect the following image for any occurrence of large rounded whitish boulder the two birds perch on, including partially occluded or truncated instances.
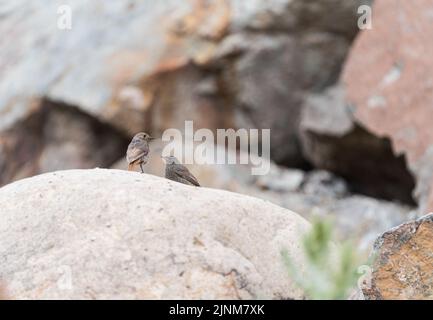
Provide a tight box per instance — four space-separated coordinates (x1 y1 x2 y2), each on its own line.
0 169 308 299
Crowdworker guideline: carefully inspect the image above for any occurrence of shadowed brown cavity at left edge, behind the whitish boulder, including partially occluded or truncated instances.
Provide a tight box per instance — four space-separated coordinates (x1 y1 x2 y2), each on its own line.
0 100 128 185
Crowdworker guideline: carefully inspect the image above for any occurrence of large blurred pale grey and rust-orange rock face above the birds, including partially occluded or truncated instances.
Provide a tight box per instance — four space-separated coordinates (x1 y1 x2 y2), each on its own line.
0 0 371 183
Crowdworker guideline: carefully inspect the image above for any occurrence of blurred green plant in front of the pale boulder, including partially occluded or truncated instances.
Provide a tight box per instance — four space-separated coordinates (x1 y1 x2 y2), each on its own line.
281 219 360 300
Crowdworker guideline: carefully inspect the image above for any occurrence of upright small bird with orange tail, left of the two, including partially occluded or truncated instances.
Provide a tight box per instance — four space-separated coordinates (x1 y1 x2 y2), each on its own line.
126 132 153 173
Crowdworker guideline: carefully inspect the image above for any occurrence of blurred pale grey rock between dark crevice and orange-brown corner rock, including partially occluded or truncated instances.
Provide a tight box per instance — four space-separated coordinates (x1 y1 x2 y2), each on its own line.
278 192 416 256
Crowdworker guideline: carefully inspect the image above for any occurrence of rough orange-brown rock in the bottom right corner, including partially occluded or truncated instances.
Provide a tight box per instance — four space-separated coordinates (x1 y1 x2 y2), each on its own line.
363 214 433 300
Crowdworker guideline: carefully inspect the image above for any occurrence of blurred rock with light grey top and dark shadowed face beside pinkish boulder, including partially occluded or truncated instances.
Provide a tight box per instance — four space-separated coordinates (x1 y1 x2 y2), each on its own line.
301 86 415 205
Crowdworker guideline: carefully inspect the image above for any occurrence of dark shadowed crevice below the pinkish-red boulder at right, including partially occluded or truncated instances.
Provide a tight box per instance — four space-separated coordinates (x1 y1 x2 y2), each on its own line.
304 124 416 205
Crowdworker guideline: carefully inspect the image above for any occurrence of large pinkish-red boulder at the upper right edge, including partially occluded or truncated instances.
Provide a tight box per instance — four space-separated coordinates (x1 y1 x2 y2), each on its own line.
342 0 433 212
